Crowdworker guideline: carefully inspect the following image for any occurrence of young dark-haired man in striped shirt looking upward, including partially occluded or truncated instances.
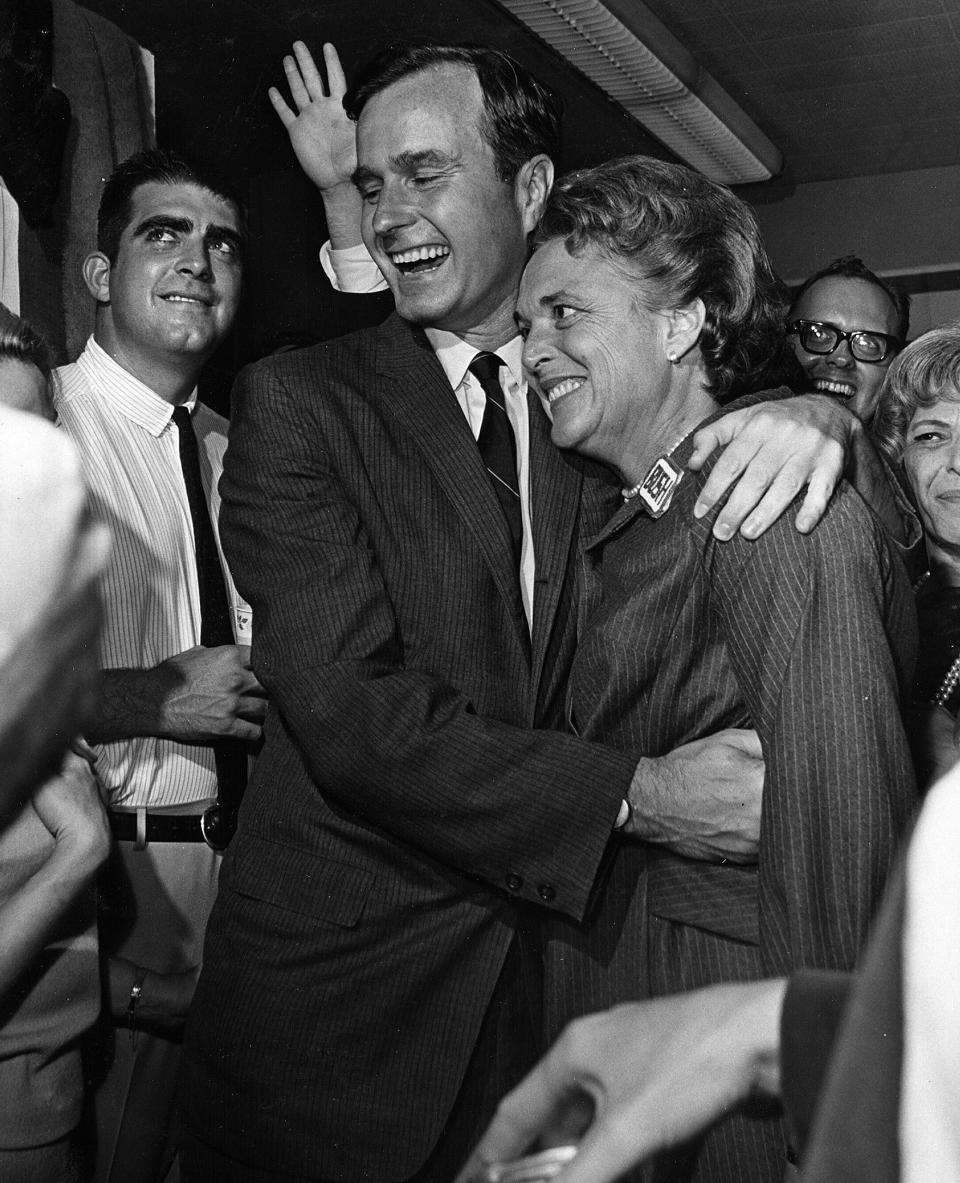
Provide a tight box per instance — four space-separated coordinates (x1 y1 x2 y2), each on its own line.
56 151 265 1183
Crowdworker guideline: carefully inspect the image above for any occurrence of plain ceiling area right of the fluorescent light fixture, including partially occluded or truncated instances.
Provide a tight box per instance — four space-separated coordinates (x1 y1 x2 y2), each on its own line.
647 0 960 183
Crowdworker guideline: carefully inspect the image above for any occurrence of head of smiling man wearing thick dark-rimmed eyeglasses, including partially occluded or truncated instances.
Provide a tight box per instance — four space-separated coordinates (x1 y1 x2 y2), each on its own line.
787 254 910 424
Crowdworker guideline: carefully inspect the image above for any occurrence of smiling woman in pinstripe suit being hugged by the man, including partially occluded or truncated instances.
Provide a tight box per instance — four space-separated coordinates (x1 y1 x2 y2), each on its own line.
517 156 915 1183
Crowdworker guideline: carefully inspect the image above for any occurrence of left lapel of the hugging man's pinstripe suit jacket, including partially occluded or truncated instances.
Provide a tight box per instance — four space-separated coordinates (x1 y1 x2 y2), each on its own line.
376 315 529 648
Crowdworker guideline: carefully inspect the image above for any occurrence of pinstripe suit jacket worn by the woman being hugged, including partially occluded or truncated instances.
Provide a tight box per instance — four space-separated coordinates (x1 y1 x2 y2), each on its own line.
547 409 916 1183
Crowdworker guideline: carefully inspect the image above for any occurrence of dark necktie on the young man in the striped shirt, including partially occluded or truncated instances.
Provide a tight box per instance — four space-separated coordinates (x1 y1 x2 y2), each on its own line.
173 407 246 849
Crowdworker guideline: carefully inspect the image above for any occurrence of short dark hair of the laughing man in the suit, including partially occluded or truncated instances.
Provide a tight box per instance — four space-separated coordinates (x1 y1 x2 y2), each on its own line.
343 44 561 181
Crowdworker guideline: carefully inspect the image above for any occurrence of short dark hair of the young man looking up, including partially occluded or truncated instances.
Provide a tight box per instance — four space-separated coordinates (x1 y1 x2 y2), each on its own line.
97 148 246 266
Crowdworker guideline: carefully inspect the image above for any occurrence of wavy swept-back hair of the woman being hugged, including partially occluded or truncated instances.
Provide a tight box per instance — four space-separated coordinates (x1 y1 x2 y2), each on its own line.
534 156 786 402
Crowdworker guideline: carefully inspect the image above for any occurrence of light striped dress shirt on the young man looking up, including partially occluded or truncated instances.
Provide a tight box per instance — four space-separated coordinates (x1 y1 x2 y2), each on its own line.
54 337 251 808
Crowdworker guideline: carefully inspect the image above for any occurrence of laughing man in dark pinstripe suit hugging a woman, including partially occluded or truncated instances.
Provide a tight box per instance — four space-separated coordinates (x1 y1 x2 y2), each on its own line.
182 46 857 1183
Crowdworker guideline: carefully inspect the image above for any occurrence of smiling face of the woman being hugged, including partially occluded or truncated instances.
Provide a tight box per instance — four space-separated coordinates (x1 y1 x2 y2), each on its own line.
517 239 671 472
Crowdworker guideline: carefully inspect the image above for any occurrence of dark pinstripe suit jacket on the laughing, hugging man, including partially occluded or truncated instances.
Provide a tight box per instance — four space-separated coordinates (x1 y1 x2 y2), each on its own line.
185 316 633 1179
